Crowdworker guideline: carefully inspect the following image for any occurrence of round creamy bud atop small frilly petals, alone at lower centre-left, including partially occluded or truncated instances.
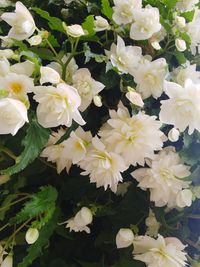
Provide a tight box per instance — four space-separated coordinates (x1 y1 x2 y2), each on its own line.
74 207 93 227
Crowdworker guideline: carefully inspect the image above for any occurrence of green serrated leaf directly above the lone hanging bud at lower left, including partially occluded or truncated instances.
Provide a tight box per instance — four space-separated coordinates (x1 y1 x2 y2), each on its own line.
9 185 58 228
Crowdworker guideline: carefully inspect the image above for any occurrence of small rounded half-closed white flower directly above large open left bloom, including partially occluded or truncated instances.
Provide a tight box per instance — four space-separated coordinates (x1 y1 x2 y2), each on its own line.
40 67 61 84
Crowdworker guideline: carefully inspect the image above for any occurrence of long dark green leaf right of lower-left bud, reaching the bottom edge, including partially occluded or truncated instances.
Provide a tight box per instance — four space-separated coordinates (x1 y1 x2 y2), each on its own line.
17 210 58 267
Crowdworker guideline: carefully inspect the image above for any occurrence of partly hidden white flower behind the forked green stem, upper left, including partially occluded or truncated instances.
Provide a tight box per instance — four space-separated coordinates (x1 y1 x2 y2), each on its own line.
47 55 78 84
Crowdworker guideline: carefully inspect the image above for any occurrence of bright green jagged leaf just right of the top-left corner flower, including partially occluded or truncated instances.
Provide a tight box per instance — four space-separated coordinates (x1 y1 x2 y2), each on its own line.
32 7 65 33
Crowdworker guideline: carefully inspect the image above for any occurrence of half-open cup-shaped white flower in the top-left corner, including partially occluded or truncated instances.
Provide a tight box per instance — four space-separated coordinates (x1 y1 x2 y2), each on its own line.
1 2 36 40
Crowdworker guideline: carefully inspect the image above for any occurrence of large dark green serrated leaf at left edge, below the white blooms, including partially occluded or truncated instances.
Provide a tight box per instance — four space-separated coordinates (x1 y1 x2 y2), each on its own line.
1 117 50 175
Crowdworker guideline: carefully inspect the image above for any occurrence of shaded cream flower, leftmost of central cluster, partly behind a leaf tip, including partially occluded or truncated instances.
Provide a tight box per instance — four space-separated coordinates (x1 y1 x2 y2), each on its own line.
40 128 72 173
